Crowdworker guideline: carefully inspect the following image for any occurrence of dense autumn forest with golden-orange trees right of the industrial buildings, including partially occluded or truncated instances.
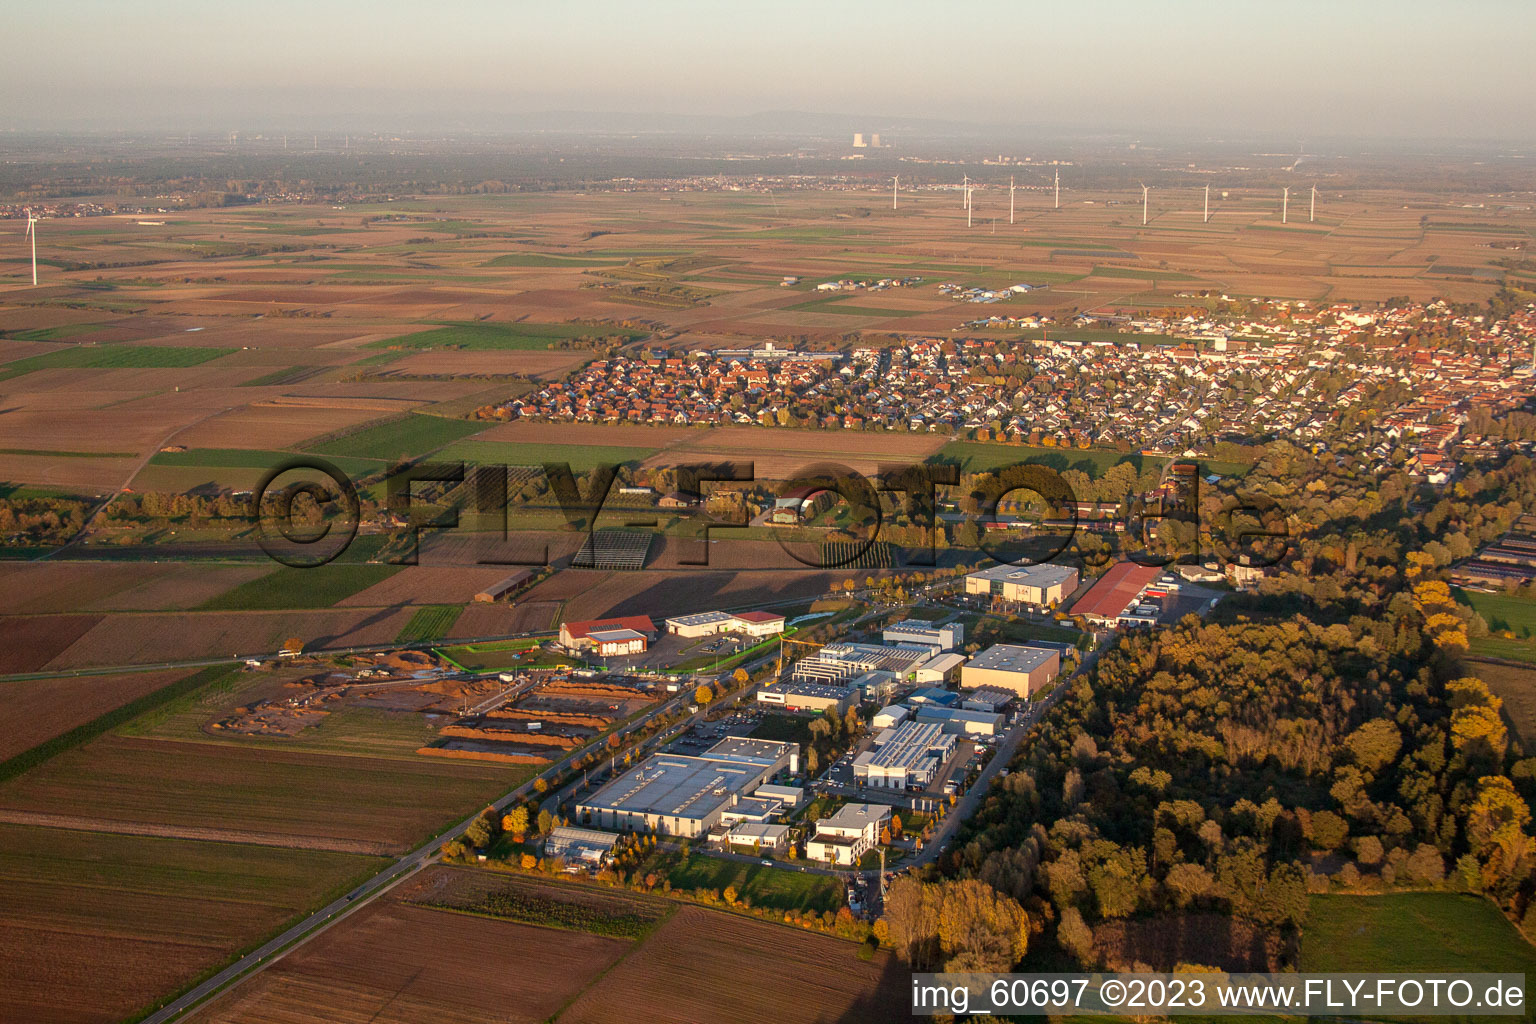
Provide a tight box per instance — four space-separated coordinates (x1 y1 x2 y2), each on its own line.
882 442 1536 970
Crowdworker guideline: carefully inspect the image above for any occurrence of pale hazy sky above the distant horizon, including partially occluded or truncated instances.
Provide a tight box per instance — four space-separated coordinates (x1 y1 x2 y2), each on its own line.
0 0 1536 141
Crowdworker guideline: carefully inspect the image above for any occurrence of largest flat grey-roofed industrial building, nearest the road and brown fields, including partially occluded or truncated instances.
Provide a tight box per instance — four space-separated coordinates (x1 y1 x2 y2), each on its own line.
576 737 800 837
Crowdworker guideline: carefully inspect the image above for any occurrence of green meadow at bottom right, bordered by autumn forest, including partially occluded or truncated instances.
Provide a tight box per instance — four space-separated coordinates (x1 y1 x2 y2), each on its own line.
1298 892 1536 975
